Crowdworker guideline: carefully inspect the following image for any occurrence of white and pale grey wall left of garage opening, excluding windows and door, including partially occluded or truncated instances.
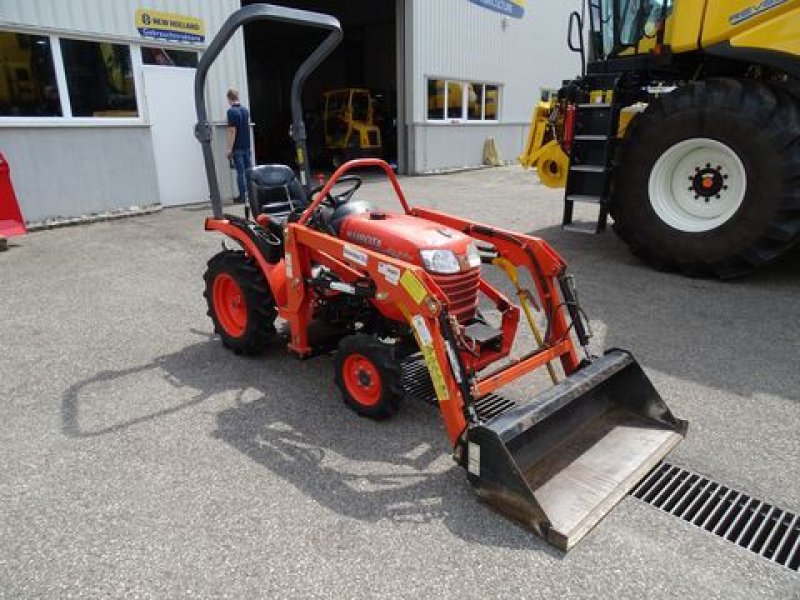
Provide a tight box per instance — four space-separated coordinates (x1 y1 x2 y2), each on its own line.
0 0 248 221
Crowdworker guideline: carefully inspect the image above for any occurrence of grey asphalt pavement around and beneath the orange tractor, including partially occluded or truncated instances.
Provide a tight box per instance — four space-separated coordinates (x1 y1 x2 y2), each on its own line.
0 167 800 600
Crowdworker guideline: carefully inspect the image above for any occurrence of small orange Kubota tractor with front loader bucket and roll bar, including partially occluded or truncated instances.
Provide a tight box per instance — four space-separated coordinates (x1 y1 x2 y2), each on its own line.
195 4 686 549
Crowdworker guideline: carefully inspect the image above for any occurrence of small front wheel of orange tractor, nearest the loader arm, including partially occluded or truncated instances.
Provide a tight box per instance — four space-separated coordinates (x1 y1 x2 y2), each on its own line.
334 333 404 420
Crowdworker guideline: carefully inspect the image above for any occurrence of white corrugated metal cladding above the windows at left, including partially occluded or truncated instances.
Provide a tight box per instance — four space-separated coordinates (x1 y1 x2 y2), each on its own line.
0 0 248 121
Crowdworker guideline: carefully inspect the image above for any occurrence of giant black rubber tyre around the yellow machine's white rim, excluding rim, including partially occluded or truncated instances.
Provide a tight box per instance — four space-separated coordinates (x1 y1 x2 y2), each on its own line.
611 79 800 278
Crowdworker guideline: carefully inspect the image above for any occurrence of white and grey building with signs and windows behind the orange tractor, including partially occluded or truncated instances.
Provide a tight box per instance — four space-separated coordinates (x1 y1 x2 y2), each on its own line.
0 0 580 223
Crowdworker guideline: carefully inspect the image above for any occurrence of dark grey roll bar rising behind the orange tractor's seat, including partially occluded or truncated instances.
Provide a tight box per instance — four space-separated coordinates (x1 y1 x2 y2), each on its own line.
194 4 342 219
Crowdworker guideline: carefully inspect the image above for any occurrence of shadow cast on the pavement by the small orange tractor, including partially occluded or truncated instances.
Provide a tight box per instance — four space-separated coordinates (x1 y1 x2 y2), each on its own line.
62 332 562 558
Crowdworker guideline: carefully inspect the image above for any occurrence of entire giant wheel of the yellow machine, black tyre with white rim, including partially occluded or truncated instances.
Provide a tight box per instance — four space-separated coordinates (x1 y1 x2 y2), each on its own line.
611 79 800 278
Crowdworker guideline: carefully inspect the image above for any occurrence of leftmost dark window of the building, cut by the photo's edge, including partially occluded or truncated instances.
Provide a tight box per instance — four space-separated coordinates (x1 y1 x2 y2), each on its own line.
0 31 62 117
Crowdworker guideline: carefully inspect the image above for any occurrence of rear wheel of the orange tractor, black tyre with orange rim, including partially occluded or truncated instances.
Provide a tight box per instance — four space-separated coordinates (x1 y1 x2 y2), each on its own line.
203 250 277 355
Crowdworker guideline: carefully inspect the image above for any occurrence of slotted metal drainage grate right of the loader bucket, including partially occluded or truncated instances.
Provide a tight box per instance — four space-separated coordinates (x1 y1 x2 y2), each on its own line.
631 463 800 571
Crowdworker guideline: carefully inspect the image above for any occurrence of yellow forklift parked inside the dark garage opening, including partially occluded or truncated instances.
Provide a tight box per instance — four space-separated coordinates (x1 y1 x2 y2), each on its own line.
324 88 383 169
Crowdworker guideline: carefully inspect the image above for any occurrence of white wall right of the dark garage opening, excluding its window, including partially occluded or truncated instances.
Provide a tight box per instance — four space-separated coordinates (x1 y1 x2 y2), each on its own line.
408 0 581 172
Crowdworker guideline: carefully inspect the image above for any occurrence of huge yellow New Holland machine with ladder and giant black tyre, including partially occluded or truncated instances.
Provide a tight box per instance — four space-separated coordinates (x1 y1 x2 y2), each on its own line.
520 0 800 278
